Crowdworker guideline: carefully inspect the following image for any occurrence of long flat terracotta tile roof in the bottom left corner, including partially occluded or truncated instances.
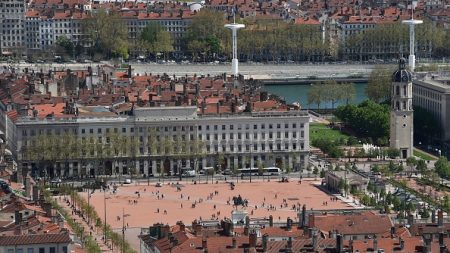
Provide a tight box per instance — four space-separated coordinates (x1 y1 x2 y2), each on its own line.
0 233 72 246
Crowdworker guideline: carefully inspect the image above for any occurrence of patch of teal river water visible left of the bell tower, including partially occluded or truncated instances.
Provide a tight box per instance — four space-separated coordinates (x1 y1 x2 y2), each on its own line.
264 83 367 109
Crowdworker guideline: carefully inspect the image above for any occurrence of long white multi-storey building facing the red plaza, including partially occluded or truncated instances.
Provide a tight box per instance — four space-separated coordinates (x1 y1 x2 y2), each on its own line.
14 106 309 177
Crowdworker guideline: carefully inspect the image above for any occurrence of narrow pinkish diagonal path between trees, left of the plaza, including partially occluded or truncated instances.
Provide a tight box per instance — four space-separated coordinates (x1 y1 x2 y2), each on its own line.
57 198 115 252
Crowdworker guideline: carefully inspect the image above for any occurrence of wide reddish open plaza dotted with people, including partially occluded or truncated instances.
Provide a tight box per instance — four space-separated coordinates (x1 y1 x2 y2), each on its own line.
83 180 352 228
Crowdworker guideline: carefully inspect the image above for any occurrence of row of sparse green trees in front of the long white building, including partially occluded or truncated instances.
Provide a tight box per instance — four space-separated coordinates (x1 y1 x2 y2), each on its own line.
22 128 204 175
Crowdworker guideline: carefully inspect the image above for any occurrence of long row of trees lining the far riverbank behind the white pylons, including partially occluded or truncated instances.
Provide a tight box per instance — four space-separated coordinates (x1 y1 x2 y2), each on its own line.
58 9 450 61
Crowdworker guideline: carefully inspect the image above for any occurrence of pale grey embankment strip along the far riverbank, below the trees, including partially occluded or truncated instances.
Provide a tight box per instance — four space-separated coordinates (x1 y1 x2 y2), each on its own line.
1 62 375 79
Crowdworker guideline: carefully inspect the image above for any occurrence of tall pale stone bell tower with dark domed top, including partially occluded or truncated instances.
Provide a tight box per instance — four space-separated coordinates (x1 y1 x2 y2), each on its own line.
390 58 413 159
